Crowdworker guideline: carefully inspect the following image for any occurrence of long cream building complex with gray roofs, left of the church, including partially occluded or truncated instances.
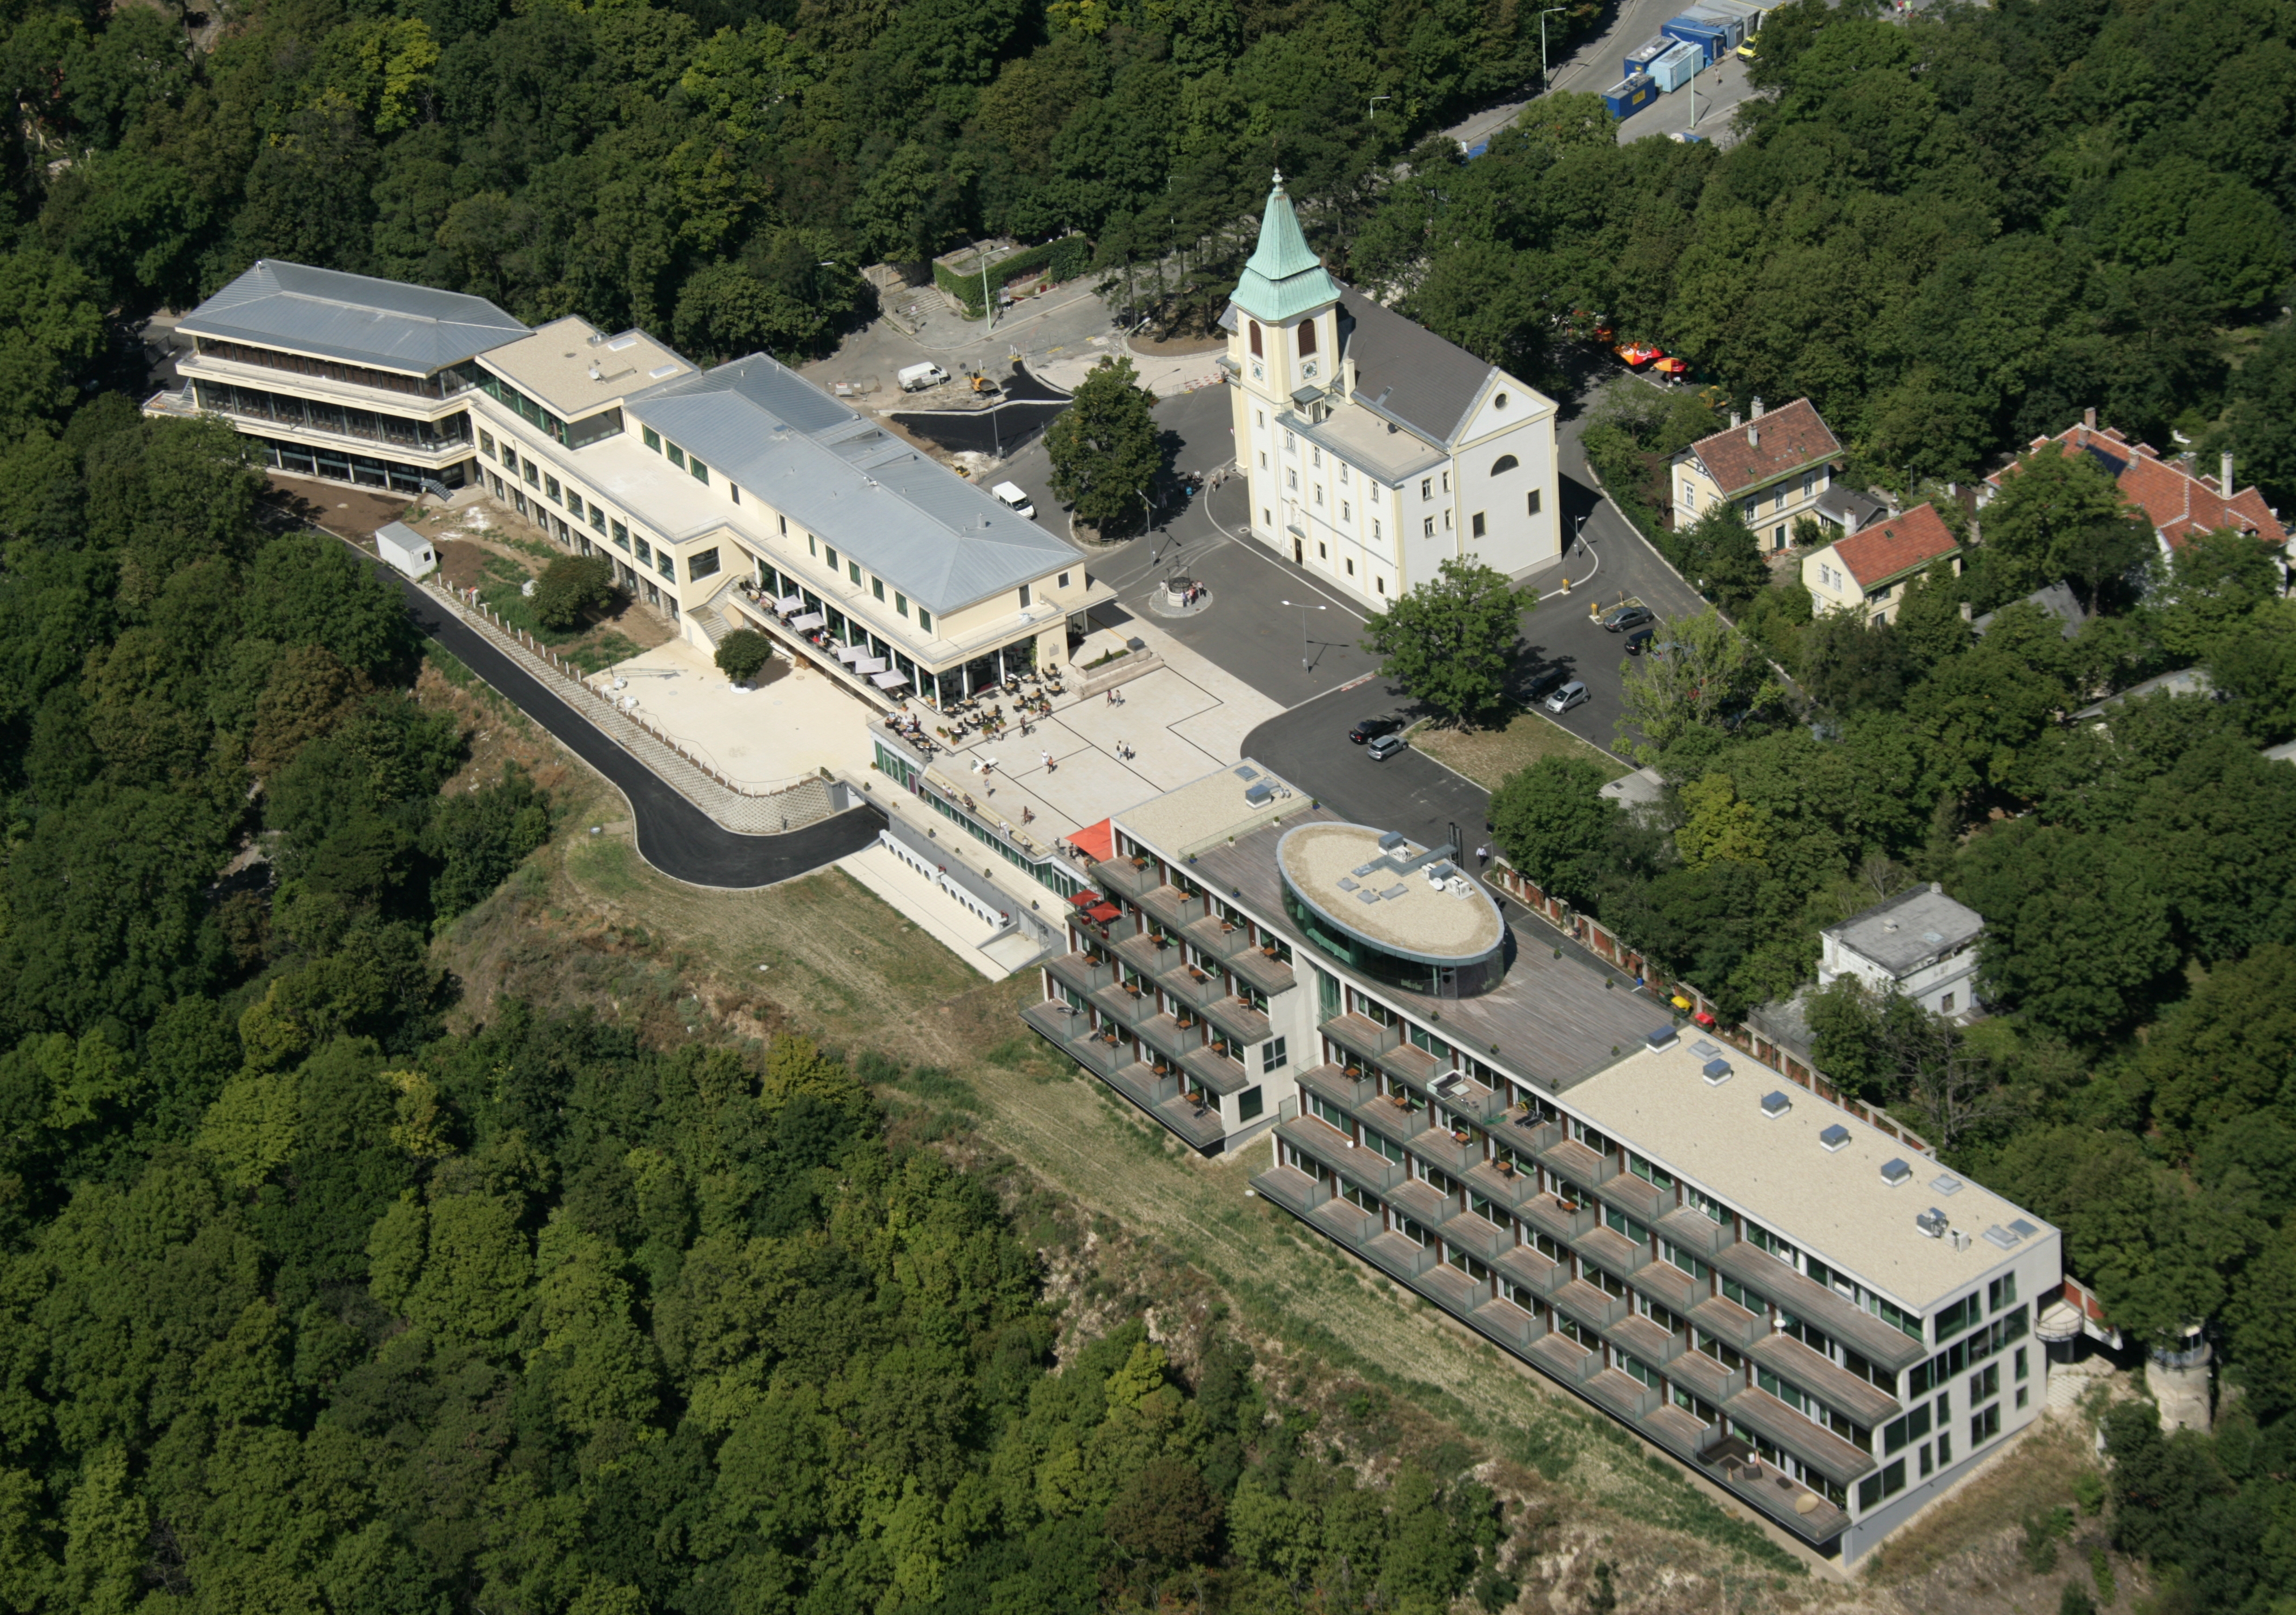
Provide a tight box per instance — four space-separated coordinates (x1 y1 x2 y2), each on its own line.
145 262 1113 708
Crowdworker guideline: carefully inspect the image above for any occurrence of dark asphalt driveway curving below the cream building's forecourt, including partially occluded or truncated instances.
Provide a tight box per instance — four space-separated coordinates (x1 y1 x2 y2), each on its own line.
384 567 884 889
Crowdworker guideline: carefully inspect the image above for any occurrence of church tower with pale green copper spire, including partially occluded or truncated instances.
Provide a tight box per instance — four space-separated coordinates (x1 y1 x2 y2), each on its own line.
1228 175 1341 560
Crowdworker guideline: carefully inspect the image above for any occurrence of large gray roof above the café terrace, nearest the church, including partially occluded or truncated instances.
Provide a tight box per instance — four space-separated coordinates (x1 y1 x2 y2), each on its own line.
625 354 1082 613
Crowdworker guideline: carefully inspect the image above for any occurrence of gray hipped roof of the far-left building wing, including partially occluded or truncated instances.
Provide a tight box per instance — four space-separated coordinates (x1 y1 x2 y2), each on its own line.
177 257 526 374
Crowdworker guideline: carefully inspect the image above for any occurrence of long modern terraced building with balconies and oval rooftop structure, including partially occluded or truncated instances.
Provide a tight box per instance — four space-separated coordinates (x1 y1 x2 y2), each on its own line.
1024 763 2064 1560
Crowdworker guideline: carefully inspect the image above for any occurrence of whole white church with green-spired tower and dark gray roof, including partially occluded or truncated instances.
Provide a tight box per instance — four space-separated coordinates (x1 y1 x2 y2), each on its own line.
1221 175 1563 609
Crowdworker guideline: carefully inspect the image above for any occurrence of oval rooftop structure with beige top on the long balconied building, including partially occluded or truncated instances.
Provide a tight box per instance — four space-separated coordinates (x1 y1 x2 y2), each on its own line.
1277 822 1506 997
